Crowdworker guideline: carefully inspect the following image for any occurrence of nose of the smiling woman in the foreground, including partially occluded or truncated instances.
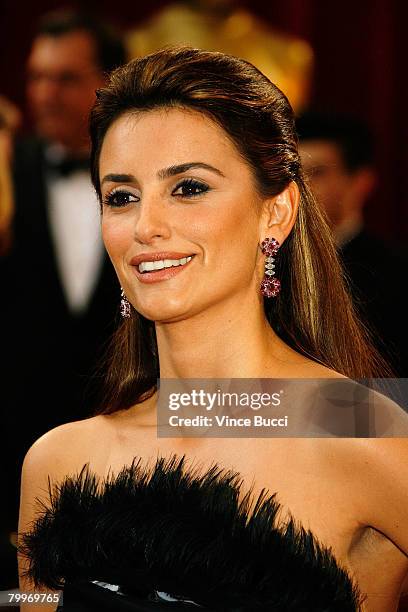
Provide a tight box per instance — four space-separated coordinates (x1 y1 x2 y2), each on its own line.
134 196 171 244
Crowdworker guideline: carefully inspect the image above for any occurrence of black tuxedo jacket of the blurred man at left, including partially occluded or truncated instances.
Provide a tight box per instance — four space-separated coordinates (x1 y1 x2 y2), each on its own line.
0 139 120 528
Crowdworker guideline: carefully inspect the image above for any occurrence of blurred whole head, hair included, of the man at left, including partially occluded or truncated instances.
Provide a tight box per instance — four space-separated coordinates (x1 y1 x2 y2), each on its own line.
27 14 112 157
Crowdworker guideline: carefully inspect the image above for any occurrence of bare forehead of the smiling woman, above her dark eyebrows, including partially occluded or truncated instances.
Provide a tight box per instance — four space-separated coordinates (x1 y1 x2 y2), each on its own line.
100 108 249 174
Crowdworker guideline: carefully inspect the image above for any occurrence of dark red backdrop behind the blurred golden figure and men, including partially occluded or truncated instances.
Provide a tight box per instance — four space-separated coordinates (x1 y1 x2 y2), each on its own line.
0 0 408 244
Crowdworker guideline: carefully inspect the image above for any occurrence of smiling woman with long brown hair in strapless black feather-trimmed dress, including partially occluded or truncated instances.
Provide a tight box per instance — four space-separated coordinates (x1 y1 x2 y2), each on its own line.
19 48 408 612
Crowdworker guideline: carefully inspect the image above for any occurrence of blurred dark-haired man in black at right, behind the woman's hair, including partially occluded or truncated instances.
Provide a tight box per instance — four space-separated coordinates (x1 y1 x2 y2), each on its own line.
297 112 408 377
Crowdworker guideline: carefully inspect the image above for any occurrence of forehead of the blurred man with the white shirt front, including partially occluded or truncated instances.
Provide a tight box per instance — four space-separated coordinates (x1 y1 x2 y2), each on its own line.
28 30 97 70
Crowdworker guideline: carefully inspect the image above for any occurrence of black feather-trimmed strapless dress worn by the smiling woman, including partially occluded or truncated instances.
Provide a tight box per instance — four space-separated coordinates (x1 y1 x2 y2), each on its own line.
20 455 361 612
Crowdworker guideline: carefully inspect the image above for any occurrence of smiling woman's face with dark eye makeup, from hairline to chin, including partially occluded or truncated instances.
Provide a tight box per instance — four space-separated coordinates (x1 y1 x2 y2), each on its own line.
100 109 264 322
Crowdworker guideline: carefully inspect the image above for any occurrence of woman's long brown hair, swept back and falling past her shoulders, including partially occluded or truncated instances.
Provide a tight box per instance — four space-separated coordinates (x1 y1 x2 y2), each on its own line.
90 47 388 414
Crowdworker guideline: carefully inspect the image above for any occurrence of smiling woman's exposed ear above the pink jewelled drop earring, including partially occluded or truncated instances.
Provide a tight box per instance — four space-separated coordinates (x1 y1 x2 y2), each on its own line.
259 181 300 244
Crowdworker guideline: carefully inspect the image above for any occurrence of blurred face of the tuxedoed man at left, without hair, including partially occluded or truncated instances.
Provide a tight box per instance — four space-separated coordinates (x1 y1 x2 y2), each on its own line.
27 30 103 151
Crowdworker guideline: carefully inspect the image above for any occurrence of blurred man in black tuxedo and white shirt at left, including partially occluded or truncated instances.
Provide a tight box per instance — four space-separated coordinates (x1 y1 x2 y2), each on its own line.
0 12 126 588
